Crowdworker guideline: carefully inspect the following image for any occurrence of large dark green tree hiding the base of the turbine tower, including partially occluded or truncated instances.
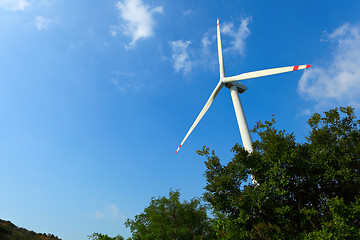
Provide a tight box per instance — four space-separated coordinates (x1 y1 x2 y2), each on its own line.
198 107 360 239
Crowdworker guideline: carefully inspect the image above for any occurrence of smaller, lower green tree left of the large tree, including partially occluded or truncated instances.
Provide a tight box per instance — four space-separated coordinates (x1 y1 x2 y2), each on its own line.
125 190 214 240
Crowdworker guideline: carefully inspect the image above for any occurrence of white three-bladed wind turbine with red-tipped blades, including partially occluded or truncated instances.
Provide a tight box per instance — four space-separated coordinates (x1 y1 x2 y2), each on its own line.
175 19 311 180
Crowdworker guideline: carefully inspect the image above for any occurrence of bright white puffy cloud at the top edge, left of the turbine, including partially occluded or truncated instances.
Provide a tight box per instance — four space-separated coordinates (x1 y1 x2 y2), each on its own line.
111 0 164 48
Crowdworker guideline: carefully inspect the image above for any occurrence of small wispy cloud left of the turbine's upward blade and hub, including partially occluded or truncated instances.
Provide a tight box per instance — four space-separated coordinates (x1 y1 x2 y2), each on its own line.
169 40 192 75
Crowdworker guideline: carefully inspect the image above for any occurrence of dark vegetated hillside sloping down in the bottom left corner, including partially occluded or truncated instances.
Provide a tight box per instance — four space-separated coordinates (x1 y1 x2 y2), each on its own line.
0 219 61 240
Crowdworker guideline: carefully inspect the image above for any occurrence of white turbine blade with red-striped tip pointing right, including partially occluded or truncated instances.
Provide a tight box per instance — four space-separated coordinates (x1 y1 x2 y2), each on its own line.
224 65 311 83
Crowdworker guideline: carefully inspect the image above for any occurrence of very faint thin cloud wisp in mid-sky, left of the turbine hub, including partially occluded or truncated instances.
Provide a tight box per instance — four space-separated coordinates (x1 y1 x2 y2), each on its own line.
111 71 144 93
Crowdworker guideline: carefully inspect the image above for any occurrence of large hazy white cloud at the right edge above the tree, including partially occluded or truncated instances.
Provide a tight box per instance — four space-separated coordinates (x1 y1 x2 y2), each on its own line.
298 23 360 108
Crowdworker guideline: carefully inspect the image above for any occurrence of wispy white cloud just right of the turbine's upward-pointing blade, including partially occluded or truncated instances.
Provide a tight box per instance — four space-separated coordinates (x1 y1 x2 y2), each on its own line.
220 18 251 56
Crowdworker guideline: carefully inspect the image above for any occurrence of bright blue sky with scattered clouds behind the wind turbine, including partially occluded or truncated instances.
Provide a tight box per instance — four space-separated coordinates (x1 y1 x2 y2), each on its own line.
0 0 360 240
